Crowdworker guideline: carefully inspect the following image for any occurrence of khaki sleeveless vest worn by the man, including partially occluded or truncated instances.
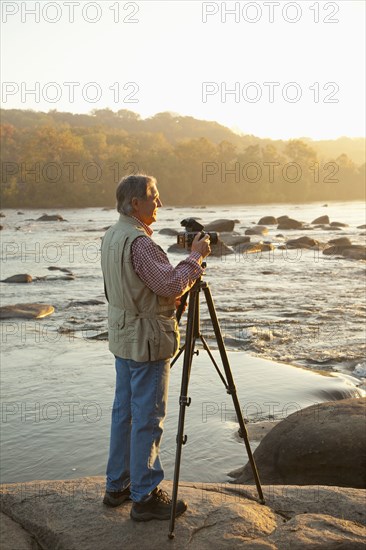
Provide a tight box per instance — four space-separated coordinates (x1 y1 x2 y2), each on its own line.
102 214 179 362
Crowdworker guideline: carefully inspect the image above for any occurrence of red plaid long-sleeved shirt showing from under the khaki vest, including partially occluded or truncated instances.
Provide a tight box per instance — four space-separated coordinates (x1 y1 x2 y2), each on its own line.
131 216 203 298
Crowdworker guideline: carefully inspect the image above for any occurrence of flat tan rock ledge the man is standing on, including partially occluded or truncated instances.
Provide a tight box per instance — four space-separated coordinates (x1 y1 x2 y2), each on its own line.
0 477 366 550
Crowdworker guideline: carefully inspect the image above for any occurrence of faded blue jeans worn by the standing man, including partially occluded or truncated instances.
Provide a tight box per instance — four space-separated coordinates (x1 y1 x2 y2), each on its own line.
106 357 170 502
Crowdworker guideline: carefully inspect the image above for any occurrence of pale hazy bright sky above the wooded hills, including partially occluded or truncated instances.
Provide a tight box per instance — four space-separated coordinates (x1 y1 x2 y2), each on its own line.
1 0 365 139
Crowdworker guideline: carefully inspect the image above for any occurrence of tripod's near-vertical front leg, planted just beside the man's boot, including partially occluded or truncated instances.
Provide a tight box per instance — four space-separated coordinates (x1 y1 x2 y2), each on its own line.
168 286 199 539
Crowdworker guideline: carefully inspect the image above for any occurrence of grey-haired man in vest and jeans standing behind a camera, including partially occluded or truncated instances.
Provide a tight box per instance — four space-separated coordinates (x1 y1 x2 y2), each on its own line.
102 174 210 521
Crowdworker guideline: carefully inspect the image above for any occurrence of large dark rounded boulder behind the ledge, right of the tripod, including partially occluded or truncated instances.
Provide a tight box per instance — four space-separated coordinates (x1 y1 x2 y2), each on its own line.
229 397 366 488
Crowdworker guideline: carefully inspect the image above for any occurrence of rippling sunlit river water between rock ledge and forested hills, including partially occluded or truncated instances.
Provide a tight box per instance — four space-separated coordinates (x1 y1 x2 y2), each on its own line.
0 202 366 481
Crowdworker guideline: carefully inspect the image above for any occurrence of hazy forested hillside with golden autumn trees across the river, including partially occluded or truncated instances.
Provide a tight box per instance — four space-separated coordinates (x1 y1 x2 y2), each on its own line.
1 109 365 208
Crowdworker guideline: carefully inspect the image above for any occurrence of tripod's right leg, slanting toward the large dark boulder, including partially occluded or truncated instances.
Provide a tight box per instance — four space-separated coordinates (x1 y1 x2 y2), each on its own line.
203 285 265 504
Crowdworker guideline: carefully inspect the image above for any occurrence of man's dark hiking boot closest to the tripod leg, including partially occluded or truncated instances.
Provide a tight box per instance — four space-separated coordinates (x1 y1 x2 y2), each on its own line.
131 487 187 521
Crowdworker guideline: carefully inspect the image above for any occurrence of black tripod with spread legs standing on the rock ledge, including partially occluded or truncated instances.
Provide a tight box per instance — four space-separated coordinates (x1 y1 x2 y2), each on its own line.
168 277 264 538
